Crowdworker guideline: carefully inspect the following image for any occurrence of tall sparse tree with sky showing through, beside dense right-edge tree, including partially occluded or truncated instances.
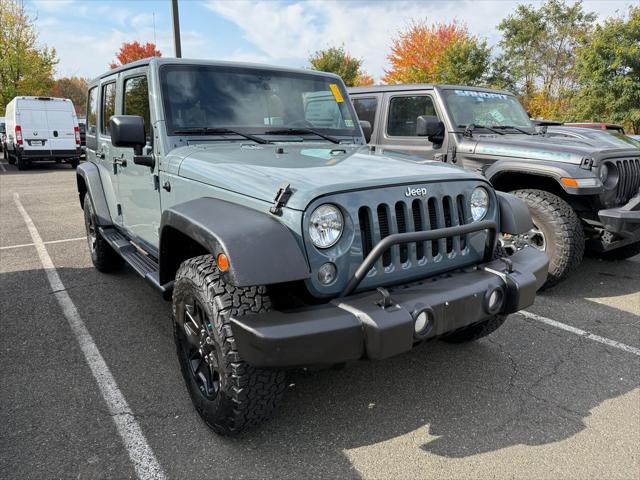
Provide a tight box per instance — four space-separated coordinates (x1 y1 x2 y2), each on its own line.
492 0 596 116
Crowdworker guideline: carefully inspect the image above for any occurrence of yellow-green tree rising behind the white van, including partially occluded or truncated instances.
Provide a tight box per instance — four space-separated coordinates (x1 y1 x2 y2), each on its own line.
0 0 58 114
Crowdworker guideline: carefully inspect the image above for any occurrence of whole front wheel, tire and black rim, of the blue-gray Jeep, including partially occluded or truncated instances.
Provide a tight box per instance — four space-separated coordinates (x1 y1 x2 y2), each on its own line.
173 255 286 435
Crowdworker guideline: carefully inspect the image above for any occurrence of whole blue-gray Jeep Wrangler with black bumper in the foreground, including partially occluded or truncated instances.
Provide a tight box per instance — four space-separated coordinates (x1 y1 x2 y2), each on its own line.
77 59 548 434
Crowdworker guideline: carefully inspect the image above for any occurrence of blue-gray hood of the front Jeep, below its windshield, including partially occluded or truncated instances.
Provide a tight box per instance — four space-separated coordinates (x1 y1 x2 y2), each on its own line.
172 143 483 210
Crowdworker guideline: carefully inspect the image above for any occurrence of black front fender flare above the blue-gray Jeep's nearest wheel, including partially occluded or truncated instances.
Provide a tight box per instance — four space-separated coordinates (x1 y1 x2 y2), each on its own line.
160 197 310 287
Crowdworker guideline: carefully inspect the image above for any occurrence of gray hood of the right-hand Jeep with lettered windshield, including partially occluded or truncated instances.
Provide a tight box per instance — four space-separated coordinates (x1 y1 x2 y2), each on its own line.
459 134 638 165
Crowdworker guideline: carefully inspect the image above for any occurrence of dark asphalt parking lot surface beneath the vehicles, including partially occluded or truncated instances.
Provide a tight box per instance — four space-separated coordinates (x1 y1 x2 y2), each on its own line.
0 155 640 479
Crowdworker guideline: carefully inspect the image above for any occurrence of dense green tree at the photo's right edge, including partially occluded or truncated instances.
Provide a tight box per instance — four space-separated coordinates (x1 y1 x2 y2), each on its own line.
573 7 640 133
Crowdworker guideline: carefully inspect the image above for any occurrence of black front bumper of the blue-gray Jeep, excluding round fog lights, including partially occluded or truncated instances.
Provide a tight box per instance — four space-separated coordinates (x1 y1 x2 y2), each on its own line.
231 248 549 368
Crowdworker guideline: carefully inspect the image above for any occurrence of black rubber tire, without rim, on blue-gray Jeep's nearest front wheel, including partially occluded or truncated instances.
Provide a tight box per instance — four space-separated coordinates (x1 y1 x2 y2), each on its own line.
173 255 286 435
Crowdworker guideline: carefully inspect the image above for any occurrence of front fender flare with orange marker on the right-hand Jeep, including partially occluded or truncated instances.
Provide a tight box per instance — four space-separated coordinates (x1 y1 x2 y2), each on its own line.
483 160 602 195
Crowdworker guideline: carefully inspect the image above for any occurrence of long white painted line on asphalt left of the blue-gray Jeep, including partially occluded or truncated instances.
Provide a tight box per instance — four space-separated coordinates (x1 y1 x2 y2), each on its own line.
13 193 165 480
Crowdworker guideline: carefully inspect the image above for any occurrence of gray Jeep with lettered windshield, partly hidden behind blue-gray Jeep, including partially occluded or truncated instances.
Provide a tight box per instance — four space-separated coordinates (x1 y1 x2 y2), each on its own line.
350 85 640 287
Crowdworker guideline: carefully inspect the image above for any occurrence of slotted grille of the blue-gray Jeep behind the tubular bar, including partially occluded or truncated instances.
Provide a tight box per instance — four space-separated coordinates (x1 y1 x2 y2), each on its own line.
358 194 470 271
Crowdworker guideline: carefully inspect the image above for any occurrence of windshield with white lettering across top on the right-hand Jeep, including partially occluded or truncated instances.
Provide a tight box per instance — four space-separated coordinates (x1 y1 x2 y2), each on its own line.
442 90 533 129
